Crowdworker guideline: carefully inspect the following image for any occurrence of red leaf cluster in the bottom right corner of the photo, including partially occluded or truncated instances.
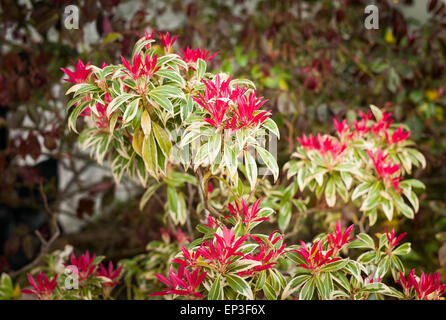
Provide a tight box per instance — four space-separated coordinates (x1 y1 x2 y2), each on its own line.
397 269 446 300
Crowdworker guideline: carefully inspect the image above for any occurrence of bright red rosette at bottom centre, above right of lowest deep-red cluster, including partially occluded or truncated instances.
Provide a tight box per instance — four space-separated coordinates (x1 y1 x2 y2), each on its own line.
197 225 248 270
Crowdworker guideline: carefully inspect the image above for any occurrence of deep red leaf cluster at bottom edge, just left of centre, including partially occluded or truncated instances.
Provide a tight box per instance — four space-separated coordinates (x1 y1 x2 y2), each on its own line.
149 265 206 298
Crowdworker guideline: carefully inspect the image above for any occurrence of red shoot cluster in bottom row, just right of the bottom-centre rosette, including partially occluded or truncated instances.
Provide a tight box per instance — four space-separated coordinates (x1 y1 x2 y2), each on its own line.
239 231 291 276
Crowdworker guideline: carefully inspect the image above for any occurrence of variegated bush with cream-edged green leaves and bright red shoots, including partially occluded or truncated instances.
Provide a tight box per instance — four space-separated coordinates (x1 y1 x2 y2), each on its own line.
14 33 446 300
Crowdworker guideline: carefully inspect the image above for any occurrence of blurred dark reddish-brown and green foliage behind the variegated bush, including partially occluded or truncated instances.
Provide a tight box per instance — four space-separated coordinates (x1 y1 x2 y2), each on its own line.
0 0 446 281
